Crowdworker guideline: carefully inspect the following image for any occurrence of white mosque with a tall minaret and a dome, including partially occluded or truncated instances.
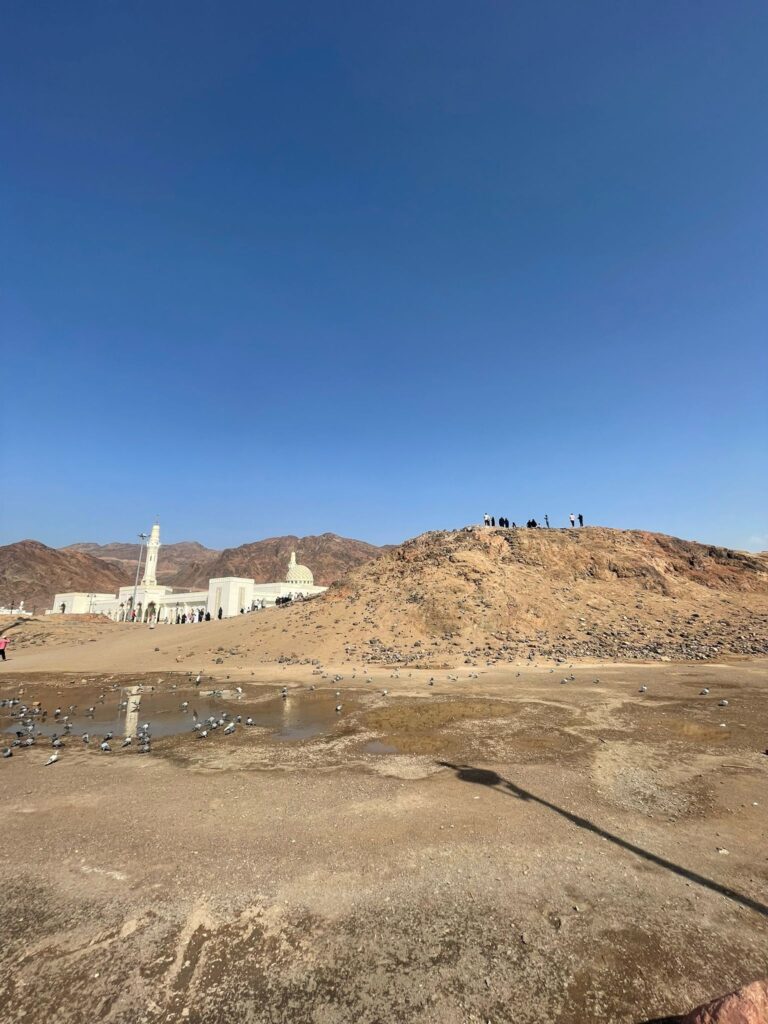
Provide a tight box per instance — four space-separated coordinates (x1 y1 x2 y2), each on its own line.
47 523 328 623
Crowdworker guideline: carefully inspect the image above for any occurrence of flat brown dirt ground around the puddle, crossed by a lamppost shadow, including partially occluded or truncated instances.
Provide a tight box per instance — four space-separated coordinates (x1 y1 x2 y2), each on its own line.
0 644 768 1024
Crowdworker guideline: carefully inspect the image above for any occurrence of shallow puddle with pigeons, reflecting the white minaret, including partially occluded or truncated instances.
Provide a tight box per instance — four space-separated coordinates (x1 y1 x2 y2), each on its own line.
0 687 354 742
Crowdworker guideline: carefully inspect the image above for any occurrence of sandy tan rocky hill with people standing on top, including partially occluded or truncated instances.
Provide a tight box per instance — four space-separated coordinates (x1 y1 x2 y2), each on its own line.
237 527 768 665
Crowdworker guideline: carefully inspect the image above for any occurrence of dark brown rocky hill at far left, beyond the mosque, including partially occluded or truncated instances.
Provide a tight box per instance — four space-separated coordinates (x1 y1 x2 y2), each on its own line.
0 541 133 612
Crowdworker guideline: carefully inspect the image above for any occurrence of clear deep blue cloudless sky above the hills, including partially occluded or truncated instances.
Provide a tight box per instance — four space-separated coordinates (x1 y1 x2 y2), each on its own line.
0 0 768 549
